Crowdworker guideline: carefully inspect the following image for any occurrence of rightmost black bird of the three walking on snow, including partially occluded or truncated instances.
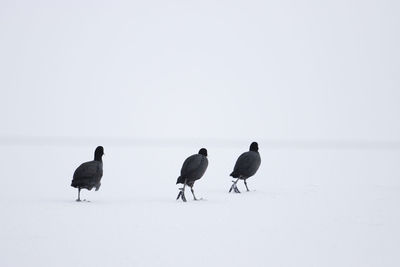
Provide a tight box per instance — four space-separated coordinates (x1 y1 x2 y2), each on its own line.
229 142 261 193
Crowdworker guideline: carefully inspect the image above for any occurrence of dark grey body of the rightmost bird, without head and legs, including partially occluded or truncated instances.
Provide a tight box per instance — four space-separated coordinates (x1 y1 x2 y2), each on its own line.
231 151 261 178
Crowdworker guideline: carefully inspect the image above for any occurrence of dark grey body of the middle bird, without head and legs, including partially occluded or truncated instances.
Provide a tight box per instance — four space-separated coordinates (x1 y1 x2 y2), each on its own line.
177 154 208 183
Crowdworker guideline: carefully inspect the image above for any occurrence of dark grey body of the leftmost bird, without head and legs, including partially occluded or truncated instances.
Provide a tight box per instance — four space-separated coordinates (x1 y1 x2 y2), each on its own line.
71 161 103 191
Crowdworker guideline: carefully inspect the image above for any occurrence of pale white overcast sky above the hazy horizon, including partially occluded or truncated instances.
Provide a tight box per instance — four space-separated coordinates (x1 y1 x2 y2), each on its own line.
0 0 400 140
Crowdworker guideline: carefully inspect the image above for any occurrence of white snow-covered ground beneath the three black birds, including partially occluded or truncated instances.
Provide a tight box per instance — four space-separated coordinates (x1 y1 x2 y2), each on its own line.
0 143 400 267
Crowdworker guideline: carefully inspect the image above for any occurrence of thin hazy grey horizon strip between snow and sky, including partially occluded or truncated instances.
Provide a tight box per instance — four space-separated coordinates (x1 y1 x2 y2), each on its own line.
0 135 400 149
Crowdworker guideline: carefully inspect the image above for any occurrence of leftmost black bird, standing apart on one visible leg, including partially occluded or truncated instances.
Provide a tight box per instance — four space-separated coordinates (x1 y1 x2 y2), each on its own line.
71 146 104 201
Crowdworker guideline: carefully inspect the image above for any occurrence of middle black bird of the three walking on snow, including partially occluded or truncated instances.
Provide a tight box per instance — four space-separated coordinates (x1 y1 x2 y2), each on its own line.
176 148 208 202
